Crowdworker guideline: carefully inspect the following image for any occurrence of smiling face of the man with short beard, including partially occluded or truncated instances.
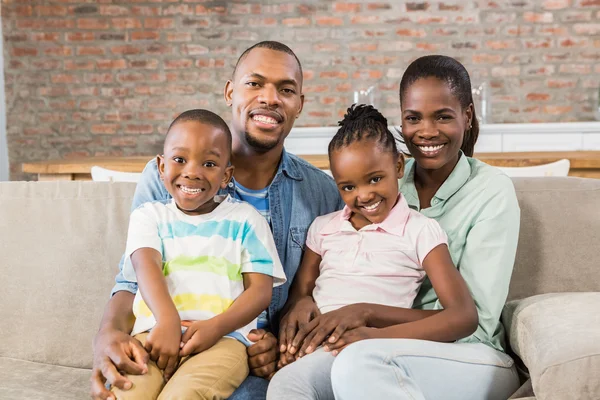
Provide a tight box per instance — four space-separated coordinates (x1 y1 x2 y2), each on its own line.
225 48 304 152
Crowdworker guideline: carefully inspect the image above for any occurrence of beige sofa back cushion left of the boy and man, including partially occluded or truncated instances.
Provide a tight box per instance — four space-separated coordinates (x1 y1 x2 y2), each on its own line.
0 182 135 368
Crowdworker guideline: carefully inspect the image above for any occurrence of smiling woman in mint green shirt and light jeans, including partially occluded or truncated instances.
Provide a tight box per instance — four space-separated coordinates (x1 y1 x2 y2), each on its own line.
331 56 520 400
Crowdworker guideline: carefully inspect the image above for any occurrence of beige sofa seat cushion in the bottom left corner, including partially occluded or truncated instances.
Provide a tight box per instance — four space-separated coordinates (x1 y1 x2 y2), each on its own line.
0 357 91 400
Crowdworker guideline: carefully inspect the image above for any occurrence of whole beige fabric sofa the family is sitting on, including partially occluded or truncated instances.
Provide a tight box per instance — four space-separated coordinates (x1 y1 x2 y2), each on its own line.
0 178 600 400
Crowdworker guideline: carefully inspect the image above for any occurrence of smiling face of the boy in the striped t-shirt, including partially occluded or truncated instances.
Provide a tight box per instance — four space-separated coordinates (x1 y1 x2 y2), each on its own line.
157 121 233 215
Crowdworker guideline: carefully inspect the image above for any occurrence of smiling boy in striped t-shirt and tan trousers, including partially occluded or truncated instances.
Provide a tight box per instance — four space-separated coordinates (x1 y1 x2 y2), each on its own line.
112 110 285 399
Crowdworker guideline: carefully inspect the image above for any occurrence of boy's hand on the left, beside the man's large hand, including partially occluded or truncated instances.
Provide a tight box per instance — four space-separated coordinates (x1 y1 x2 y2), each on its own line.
144 316 181 380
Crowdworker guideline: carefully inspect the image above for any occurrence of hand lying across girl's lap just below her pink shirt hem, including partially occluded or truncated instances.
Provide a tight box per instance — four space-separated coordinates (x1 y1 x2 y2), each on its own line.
290 303 369 357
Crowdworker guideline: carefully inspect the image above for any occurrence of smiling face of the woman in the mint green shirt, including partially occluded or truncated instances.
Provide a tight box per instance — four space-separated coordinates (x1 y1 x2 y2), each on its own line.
402 77 473 172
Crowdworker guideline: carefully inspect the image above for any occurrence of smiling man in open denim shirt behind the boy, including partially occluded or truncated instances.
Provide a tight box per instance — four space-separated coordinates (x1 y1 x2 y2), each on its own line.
91 41 343 400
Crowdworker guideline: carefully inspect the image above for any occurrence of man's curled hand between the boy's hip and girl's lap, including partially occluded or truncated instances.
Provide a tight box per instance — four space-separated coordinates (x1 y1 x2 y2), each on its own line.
247 329 278 379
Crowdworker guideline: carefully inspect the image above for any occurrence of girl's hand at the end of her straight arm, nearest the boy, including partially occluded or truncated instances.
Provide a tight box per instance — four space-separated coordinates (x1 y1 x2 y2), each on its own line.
279 296 321 354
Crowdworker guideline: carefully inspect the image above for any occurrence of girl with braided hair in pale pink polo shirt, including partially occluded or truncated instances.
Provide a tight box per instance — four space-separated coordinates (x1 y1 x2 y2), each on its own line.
267 105 477 400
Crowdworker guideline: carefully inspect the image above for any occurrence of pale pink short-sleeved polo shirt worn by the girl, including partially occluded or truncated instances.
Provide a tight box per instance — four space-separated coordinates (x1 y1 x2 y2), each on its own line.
306 194 448 313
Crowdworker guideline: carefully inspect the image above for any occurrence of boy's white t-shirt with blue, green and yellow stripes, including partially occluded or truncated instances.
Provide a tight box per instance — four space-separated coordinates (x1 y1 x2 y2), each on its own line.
123 196 286 344
